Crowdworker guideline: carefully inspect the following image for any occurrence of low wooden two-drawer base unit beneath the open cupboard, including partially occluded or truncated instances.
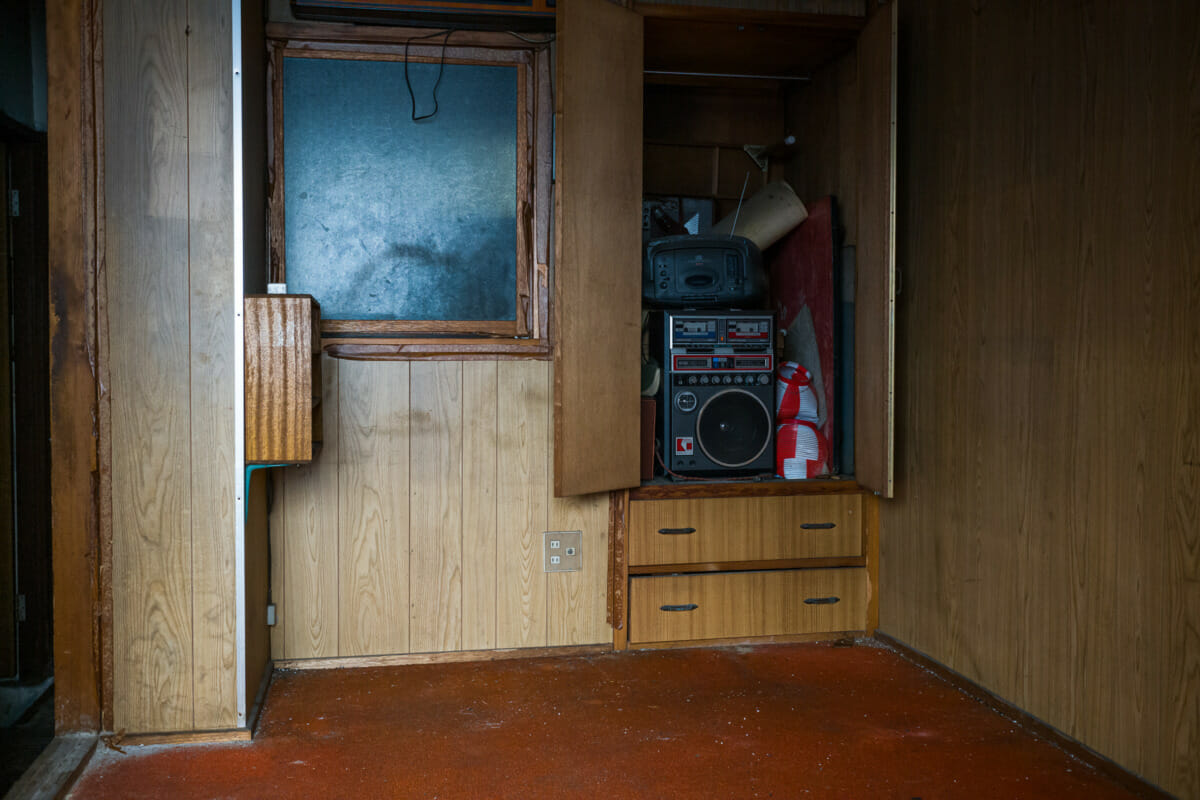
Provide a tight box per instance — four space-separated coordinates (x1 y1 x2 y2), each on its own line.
613 481 878 648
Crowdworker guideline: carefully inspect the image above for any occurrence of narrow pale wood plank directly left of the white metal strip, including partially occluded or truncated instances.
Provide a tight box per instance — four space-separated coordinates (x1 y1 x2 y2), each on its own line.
187 0 241 729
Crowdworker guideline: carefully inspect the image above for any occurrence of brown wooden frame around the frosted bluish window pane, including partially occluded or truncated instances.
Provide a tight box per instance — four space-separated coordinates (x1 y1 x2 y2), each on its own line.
266 23 553 359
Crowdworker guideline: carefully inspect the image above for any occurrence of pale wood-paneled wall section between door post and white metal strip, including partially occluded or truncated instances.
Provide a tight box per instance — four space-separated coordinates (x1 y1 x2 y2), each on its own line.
101 0 238 733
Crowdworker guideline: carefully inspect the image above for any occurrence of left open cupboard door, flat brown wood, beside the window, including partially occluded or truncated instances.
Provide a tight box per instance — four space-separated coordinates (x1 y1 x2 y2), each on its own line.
553 0 642 497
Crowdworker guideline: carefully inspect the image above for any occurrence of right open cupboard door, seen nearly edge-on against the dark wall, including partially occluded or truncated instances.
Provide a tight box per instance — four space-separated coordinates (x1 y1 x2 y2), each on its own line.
854 2 896 498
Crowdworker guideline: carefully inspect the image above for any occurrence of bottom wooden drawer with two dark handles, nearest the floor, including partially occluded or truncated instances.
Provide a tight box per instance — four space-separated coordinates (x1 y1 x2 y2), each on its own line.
629 567 870 644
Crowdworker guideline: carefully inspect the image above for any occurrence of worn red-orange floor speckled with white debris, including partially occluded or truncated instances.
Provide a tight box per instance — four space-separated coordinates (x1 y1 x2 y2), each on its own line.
70 643 1133 800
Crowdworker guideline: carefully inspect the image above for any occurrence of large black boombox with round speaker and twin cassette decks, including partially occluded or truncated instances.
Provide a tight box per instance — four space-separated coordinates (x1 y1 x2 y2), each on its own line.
654 311 775 476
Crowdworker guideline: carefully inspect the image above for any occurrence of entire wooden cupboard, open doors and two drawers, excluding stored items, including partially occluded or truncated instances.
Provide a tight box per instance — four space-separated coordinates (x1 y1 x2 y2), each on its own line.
554 0 896 648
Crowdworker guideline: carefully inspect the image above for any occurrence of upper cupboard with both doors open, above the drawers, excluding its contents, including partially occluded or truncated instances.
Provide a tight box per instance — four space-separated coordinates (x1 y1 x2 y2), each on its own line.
554 0 895 497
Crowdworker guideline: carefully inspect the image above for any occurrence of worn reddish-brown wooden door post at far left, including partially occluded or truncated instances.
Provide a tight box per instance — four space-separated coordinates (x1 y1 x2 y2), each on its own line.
46 0 110 734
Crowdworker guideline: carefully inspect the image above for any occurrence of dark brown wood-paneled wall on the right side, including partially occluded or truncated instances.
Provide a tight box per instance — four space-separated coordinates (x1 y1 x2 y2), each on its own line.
880 0 1200 798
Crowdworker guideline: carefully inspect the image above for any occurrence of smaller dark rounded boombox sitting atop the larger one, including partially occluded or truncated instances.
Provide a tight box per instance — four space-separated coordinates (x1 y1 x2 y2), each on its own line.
642 234 767 308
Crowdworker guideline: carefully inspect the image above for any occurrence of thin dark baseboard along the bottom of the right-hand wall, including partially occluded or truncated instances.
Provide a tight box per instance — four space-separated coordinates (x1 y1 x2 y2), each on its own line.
875 631 1175 800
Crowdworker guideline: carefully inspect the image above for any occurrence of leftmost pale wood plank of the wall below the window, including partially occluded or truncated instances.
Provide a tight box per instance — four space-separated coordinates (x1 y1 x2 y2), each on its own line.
279 357 343 658
